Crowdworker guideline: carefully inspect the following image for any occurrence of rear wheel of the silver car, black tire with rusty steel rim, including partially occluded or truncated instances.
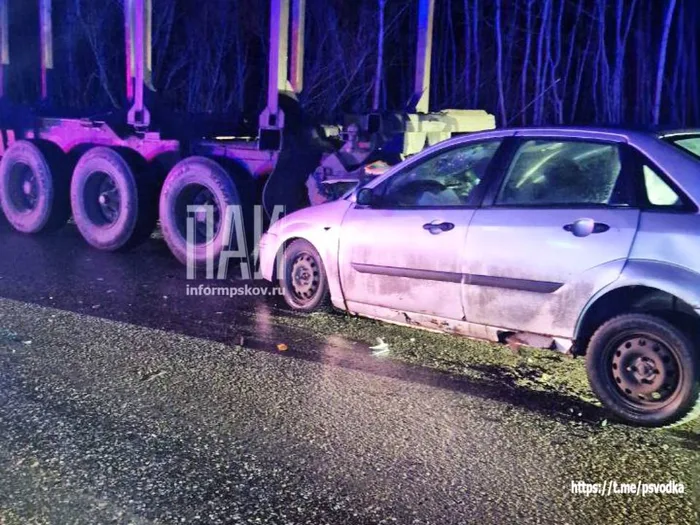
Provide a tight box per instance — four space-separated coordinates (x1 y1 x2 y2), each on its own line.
586 314 700 427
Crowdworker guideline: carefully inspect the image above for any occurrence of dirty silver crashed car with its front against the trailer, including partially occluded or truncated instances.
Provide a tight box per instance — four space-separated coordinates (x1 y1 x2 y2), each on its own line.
260 128 700 426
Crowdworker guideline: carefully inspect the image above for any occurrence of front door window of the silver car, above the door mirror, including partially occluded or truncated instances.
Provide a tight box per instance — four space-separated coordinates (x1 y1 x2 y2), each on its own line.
379 140 501 208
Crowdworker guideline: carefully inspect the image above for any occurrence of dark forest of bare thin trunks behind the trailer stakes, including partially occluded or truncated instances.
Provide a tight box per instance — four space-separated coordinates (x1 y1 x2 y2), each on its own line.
8 0 700 126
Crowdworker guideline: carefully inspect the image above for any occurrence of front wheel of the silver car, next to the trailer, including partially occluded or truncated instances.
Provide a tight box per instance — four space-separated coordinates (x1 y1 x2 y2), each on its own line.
280 239 331 312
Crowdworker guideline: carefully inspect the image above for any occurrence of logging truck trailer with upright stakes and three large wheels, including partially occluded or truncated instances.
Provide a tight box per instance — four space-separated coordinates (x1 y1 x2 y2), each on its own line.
0 0 494 264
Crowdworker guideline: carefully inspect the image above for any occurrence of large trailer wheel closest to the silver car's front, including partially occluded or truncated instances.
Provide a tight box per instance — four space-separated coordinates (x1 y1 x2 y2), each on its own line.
159 157 242 266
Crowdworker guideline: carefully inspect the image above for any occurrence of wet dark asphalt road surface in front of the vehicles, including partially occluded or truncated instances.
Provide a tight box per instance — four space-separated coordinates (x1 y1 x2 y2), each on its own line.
0 215 700 525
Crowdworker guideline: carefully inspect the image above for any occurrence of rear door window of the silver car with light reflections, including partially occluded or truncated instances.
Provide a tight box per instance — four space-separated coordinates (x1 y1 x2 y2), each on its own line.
496 140 629 206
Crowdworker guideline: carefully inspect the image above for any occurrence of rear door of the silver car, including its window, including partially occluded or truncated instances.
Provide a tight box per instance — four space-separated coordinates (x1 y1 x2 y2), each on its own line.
463 135 639 337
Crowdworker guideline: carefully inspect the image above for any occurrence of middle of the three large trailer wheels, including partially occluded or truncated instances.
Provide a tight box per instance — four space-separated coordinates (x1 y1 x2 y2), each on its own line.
70 146 157 251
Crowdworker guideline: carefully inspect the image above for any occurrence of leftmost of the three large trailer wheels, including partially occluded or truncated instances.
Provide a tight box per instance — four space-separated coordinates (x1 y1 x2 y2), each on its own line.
0 140 70 233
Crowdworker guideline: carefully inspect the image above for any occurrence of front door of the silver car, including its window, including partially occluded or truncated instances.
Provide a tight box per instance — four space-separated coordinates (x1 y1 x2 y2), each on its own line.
339 139 501 319
